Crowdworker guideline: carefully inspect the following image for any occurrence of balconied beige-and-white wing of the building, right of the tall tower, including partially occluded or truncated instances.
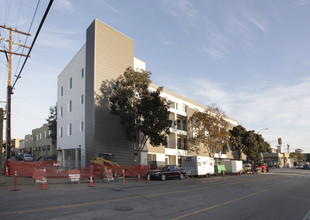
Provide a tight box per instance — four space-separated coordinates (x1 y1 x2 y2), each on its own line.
141 84 239 165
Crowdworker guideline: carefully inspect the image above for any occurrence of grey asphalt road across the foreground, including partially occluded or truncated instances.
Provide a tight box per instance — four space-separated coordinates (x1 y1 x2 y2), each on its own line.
0 169 310 220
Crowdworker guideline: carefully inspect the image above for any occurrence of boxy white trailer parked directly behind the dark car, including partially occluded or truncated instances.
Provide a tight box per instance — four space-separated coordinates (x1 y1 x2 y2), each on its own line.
181 156 214 177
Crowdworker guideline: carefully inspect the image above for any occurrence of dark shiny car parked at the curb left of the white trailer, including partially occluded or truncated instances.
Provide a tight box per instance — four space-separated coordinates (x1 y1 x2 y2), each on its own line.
148 165 186 181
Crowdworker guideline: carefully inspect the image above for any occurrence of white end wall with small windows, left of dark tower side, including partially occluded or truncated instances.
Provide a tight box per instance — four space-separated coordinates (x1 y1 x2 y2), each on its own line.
57 46 86 167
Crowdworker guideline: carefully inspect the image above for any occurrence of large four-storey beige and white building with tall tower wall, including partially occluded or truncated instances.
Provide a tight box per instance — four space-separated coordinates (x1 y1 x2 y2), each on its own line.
57 19 237 168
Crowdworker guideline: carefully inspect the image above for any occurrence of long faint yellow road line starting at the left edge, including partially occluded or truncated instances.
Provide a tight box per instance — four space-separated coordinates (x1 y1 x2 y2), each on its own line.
0 180 276 216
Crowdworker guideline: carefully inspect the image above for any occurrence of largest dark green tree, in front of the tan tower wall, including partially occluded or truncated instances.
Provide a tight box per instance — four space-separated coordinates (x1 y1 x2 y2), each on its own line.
109 67 172 164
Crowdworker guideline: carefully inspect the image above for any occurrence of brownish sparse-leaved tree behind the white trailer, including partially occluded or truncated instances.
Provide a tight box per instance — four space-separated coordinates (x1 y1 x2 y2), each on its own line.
188 104 230 157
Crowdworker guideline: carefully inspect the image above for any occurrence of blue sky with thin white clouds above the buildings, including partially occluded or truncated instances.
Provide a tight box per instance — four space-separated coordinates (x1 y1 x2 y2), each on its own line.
0 0 310 152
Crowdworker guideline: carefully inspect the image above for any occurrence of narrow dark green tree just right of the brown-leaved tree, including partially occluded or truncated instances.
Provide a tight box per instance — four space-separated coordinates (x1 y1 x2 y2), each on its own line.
229 125 247 160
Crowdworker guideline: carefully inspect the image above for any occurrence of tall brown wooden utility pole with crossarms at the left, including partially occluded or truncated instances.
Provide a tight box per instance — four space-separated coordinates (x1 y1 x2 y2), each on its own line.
0 25 31 159
